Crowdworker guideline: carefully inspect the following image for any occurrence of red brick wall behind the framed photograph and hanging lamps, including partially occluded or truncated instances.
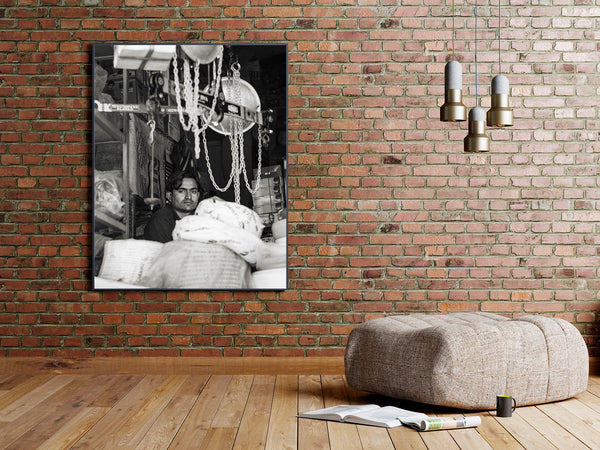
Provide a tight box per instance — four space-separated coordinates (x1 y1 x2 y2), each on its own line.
0 0 600 356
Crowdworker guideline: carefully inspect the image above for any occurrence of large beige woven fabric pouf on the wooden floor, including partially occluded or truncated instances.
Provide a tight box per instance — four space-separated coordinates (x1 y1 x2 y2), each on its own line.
345 313 589 410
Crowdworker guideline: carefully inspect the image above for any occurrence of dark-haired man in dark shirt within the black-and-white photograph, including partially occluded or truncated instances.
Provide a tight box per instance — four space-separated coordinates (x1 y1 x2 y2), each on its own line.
144 171 203 242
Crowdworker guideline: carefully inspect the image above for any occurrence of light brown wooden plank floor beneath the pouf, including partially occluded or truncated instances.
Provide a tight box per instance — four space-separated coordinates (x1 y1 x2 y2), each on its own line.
0 373 600 450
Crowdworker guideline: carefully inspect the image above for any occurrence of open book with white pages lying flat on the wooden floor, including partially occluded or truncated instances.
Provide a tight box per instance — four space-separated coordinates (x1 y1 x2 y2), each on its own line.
298 405 427 428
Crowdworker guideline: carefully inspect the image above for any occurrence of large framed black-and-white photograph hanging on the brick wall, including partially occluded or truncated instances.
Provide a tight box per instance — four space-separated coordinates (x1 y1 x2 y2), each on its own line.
93 43 288 290
